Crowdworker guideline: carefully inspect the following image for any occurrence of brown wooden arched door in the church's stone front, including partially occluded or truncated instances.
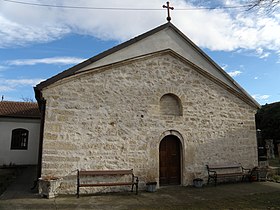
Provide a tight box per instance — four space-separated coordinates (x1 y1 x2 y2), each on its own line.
159 135 181 185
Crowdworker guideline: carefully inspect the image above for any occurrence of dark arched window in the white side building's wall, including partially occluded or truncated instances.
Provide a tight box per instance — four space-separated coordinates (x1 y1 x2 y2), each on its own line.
11 128 29 150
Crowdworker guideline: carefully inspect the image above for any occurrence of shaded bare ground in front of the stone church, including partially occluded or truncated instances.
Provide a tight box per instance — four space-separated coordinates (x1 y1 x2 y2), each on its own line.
0 168 280 210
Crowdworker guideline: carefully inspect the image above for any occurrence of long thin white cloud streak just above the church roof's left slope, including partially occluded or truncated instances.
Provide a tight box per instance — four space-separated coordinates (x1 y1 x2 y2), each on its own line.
6 57 85 66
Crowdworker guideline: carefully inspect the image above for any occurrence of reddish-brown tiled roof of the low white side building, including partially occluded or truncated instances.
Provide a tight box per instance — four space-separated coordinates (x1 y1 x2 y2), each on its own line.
0 101 41 119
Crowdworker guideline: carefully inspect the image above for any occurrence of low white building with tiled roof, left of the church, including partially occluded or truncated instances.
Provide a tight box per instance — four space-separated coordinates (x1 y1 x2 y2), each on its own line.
0 101 40 166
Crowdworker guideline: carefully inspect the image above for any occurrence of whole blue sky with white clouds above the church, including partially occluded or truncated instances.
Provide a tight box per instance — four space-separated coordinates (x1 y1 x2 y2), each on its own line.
0 0 280 104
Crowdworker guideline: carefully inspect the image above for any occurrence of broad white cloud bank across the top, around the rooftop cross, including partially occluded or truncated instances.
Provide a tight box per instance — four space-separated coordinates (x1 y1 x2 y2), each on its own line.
0 0 280 58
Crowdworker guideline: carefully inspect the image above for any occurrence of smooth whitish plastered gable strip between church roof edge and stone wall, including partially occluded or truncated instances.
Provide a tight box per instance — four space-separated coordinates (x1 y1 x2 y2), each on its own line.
78 27 243 96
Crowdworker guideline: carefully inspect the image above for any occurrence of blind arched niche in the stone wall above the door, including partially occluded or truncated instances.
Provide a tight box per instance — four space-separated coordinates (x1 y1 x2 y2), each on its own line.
160 93 183 116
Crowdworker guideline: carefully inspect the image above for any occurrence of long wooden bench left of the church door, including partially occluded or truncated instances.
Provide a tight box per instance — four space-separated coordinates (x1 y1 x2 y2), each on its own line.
77 169 139 198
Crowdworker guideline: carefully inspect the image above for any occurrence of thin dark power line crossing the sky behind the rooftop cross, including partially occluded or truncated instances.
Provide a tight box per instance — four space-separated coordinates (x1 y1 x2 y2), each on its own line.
2 0 253 11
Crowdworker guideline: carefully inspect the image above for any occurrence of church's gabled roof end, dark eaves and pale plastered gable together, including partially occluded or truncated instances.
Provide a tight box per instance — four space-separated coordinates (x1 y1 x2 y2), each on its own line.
34 22 260 108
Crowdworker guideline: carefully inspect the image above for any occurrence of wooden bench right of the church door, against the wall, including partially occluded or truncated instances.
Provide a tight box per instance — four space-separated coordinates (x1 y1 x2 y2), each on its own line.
206 163 251 186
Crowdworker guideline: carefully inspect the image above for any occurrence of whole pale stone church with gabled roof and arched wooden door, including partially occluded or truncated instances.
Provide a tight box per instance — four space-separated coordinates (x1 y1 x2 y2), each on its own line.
34 22 259 194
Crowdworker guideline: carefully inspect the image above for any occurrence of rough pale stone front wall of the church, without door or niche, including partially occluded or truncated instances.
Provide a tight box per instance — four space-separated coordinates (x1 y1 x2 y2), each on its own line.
42 53 257 193
